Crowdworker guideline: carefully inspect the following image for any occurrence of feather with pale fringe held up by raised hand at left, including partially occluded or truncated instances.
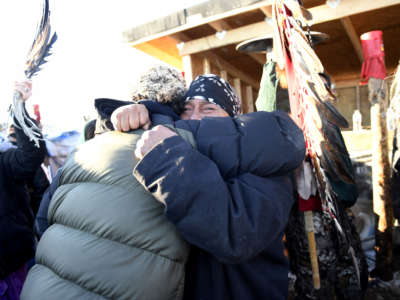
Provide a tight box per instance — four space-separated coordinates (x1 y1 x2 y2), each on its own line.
10 0 57 147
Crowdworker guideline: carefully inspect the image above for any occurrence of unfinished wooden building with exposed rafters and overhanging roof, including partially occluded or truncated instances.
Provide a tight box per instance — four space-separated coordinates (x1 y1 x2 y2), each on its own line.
124 0 400 127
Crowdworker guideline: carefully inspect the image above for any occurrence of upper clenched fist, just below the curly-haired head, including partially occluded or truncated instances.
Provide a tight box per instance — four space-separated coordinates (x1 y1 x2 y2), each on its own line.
111 104 151 131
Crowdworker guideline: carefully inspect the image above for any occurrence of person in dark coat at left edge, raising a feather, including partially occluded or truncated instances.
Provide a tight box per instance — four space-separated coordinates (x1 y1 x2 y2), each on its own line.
0 82 46 299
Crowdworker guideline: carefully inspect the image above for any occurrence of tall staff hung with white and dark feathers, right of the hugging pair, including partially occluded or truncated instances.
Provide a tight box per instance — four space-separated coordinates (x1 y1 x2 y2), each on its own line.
272 0 360 282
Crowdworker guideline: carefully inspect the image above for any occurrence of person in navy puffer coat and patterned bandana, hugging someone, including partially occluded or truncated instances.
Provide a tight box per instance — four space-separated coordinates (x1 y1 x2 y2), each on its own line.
112 75 305 300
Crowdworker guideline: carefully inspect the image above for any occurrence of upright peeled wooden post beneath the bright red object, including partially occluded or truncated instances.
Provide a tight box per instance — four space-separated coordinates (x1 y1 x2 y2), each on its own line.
368 78 393 281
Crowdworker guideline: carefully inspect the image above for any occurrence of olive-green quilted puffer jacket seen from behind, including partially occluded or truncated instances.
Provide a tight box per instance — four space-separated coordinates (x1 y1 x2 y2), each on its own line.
21 131 189 300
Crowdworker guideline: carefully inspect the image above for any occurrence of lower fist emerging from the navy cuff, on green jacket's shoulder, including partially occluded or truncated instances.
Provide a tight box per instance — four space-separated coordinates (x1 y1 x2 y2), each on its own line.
135 125 177 159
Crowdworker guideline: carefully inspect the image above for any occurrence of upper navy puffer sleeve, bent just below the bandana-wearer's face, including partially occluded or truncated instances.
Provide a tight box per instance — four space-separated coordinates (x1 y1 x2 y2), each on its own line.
175 112 305 178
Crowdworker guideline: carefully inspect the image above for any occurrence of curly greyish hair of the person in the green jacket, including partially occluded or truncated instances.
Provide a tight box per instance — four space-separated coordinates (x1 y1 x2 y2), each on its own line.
131 65 186 114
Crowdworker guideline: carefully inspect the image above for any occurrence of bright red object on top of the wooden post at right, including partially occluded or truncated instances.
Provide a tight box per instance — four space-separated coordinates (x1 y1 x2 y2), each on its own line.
361 30 386 83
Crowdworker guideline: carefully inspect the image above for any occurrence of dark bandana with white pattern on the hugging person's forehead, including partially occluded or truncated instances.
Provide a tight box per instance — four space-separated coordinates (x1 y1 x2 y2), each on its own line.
183 74 241 117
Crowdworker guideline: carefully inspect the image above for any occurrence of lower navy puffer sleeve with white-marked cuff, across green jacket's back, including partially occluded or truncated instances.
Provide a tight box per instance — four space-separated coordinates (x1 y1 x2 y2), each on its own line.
134 136 293 263
